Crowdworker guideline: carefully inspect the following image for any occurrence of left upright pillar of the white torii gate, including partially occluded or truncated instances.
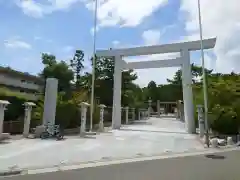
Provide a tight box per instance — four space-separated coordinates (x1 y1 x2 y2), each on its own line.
112 56 122 129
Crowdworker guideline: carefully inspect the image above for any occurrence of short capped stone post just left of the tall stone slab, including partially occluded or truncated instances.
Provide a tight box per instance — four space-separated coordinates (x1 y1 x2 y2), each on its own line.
23 102 36 137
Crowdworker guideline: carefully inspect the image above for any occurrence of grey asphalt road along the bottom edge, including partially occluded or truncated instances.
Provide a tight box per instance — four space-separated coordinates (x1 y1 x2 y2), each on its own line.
0 150 240 180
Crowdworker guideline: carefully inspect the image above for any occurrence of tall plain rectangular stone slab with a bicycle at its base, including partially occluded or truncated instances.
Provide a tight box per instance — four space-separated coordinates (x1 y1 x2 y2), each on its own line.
43 78 58 126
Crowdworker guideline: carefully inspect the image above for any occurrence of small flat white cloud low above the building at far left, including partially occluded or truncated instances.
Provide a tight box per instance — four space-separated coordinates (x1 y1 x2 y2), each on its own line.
4 38 32 49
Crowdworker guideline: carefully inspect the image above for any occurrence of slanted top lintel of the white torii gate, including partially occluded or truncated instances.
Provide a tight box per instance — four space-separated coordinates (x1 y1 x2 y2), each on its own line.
96 38 217 57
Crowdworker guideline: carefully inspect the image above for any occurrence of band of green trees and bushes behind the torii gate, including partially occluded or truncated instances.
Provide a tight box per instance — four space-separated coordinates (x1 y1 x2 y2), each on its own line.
0 50 240 134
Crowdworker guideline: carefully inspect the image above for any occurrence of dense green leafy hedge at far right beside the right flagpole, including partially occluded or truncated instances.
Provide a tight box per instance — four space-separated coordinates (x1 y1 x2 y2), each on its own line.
194 74 240 135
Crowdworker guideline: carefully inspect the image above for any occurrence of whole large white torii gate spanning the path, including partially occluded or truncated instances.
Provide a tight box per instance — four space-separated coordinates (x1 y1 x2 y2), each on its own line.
96 38 216 133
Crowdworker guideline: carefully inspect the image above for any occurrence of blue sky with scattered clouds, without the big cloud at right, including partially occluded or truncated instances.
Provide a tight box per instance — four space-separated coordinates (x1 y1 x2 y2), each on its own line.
0 0 239 86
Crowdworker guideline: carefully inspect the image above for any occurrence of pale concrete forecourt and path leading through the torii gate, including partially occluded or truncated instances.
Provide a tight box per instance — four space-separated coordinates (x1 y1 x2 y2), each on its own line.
0 118 204 170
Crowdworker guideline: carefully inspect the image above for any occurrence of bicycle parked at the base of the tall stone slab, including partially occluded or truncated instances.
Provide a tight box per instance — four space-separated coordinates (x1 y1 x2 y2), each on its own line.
40 124 63 140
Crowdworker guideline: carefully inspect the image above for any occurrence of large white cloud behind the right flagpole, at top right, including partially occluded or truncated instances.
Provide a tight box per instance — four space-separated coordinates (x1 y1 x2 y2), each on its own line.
181 0 240 72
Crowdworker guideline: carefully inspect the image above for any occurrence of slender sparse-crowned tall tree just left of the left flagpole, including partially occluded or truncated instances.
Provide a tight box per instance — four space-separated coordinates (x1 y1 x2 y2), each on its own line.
70 50 84 89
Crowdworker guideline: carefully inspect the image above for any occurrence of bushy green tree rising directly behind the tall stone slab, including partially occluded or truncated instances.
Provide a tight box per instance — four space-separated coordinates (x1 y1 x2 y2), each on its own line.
40 53 74 92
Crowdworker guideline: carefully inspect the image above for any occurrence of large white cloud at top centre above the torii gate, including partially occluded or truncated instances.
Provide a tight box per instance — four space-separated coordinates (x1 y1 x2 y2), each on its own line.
85 0 168 27
